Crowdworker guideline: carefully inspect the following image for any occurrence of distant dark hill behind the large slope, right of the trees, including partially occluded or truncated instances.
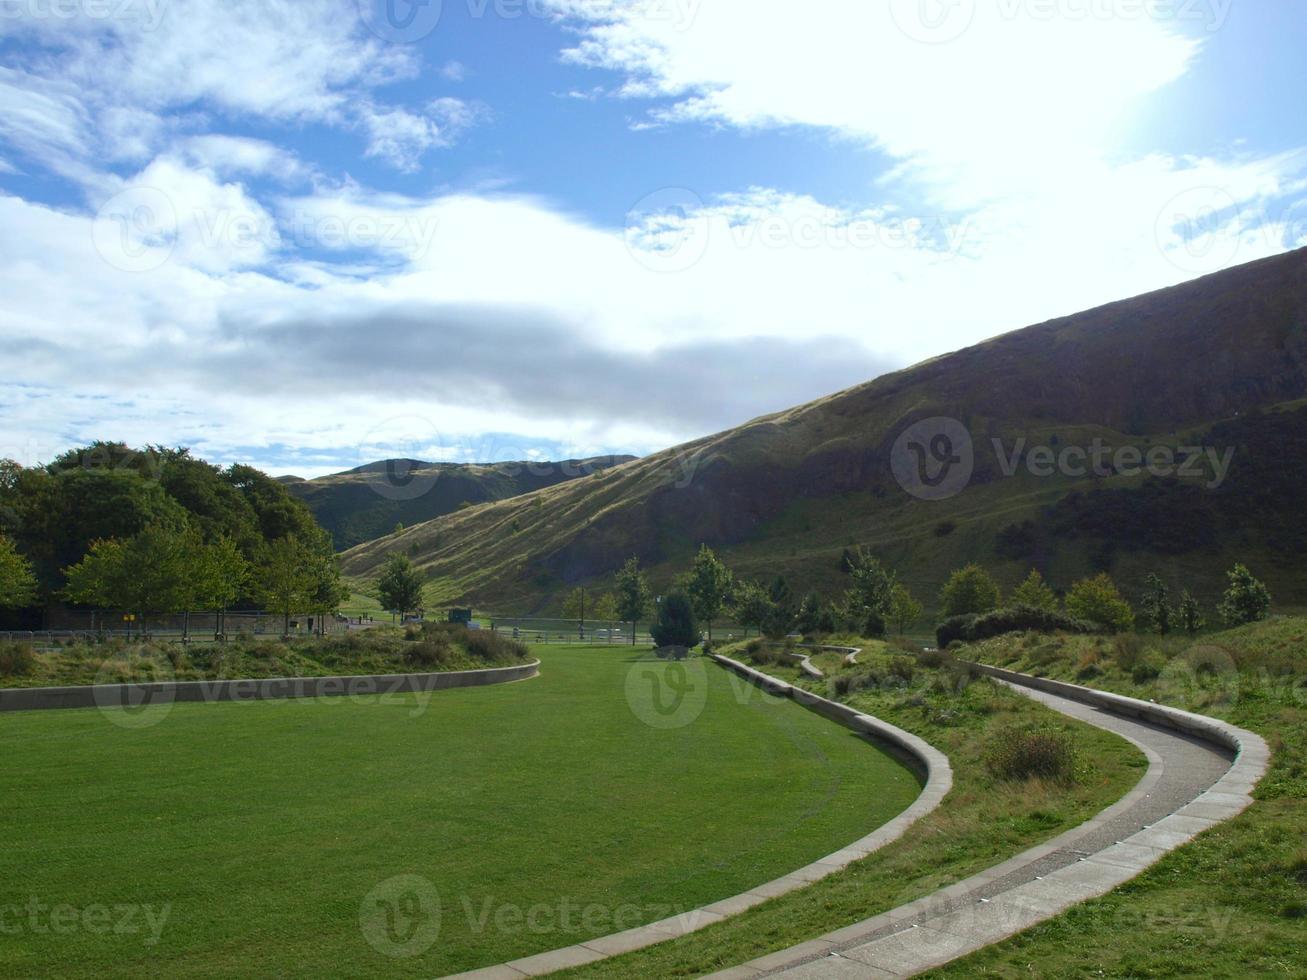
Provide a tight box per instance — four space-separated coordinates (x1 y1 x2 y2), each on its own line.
281 456 635 550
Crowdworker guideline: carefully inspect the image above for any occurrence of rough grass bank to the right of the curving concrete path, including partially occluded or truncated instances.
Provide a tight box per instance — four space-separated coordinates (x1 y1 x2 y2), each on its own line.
933 617 1307 977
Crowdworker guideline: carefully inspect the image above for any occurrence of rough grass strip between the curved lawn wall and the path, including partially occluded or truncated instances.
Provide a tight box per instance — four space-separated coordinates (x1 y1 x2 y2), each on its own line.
551 638 1148 980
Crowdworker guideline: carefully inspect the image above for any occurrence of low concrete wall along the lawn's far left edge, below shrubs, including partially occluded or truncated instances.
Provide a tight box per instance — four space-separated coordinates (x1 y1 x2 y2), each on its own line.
0 660 540 712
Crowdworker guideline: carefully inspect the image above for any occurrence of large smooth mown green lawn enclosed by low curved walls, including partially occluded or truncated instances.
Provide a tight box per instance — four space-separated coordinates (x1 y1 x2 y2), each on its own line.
0 647 919 977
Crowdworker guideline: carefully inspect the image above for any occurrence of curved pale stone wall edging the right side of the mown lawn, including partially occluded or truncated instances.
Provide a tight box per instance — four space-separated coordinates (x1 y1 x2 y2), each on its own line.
444 653 953 980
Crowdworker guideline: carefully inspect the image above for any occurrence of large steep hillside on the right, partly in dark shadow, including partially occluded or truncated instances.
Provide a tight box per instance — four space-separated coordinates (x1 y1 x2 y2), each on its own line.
344 250 1307 612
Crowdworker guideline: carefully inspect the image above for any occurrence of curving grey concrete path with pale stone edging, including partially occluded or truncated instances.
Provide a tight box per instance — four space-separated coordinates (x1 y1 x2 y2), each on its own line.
714 679 1269 980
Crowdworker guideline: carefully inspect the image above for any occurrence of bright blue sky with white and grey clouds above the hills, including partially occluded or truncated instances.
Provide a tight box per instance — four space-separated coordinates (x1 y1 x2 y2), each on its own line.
0 0 1307 477
